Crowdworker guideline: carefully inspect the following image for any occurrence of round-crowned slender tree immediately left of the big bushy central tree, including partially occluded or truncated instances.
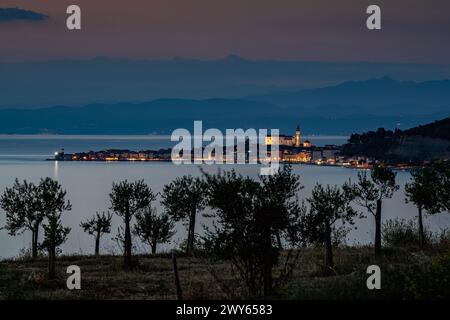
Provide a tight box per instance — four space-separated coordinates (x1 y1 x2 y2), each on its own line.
162 176 206 254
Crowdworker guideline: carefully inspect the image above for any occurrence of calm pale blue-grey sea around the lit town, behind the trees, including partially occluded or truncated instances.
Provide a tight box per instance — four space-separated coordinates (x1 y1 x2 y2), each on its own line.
0 136 450 257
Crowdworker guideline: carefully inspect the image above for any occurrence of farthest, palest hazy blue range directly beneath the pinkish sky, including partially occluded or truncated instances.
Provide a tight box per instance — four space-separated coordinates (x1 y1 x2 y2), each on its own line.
0 55 450 109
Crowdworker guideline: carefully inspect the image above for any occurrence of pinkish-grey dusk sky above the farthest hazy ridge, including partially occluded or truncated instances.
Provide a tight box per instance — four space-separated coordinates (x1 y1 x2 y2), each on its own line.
0 0 450 64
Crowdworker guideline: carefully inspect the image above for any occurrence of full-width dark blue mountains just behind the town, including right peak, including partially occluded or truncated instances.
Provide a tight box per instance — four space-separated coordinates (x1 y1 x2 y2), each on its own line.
0 77 450 135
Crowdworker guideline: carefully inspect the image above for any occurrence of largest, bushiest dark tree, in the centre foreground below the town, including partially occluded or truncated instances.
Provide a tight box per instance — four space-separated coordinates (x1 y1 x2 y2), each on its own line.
205 168 301 297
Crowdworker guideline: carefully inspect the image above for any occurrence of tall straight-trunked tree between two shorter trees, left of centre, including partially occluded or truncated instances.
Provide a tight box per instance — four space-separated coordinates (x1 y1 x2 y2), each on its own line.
109 180 156 270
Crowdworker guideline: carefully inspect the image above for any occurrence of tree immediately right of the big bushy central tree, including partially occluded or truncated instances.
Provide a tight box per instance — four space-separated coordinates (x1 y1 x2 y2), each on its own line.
305 184 358 271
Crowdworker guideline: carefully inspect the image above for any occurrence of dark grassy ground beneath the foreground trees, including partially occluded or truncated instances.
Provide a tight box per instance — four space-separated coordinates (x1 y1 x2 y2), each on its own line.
0 247 450 299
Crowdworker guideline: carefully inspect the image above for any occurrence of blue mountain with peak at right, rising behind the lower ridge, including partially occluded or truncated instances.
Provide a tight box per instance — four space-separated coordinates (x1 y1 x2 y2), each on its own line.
250 77 450 116
